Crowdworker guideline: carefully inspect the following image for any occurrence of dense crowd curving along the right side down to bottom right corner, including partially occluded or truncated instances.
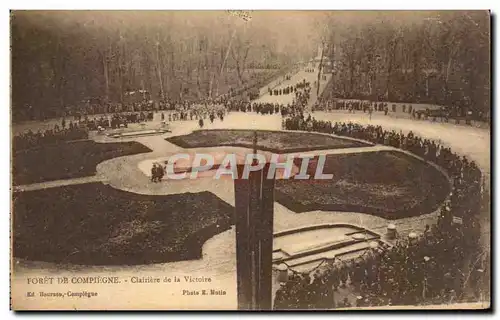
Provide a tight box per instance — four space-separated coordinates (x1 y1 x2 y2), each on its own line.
275 114 490 309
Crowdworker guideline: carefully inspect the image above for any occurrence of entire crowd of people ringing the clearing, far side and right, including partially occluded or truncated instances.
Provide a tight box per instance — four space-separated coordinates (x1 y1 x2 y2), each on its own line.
13 63 490 309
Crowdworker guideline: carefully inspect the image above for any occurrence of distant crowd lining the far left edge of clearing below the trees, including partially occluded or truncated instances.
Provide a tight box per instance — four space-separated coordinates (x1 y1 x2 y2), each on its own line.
13 73 310 150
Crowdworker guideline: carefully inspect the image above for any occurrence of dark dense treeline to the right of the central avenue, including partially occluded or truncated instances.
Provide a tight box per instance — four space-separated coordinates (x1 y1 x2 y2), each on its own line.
324 11 490 112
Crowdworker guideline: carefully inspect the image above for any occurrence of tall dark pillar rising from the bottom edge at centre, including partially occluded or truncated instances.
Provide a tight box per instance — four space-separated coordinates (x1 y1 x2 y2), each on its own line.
234 156 275 310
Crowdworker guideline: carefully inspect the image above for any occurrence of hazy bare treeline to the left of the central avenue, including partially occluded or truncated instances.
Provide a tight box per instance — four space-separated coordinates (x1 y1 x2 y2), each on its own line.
11 11 318 119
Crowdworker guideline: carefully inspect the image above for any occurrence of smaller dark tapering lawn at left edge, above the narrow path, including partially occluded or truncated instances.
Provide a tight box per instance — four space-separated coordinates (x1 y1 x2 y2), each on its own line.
12 140 151 185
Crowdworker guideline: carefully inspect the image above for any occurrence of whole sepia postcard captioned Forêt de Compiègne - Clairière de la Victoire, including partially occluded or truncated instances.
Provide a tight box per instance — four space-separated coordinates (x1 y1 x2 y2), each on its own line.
10 10 492 311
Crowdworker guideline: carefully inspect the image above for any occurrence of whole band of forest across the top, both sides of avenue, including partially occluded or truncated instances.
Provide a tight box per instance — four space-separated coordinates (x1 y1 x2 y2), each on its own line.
11 11 490 120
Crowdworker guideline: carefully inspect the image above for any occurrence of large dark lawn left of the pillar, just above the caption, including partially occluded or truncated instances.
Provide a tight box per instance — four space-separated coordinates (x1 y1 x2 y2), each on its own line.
12 183 234 265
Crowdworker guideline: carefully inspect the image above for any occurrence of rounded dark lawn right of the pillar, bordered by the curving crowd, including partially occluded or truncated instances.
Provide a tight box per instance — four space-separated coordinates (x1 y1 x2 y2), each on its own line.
275 151 450 219
